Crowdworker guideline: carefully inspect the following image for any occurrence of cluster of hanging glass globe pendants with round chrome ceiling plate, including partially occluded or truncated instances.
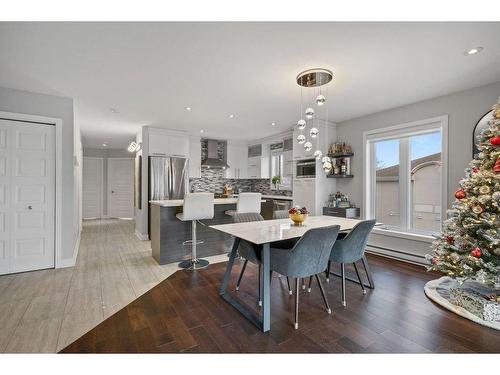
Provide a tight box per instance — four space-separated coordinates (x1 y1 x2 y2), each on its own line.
296 68 333 160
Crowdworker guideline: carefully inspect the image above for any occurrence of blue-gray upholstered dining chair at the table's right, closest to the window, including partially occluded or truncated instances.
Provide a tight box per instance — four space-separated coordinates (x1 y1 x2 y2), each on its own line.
320 220 375 306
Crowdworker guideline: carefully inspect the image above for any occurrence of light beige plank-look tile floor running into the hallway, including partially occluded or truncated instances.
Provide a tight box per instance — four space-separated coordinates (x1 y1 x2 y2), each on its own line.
0 219 227 353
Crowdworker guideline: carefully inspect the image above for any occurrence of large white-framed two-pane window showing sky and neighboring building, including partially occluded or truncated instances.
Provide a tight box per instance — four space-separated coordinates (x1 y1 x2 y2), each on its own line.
364 117 447 235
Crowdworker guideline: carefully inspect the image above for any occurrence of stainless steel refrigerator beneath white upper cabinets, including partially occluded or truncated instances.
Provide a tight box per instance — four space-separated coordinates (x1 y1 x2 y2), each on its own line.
149 156 189 200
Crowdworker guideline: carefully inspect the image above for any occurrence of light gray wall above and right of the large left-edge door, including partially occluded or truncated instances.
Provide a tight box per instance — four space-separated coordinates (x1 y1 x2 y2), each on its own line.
0 87 79 264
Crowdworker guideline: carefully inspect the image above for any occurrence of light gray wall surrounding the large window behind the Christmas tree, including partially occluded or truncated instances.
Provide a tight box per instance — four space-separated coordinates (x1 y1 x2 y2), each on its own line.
337 82 500 261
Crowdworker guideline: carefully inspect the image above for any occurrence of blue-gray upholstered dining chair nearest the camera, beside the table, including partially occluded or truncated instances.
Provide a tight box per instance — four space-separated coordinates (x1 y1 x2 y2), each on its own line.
271 225 340 329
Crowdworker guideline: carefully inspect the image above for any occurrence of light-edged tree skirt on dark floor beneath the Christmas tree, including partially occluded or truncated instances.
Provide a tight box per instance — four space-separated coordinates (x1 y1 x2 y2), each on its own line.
424 276 500 331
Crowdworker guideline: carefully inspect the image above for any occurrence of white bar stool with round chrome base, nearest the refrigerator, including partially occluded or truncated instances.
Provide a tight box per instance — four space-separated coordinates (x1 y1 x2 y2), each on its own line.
175 193 214 270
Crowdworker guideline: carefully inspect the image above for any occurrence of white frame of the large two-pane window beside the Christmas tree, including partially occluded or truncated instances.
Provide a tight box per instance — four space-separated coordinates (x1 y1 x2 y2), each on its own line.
362 115 448 238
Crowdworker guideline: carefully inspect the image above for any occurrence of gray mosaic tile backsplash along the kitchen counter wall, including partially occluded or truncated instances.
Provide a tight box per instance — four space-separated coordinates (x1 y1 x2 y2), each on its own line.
189 168 292 196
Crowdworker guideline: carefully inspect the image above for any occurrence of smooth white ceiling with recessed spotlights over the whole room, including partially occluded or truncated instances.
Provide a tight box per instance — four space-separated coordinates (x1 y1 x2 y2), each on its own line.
0 22 500 148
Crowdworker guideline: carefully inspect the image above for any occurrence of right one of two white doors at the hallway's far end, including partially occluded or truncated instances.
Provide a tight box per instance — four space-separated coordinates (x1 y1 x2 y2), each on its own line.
108 158 134 218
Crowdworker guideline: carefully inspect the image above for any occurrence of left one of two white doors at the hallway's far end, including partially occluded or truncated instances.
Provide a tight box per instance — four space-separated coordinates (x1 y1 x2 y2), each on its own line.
82 157 103 219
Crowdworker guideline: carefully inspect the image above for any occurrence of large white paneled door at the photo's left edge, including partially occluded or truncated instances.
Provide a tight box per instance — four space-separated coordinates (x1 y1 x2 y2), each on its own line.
0 120 55 273
